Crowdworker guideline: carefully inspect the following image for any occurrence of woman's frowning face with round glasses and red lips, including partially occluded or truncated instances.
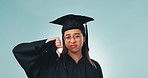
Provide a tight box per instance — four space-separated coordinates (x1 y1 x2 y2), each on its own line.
64 29 85 53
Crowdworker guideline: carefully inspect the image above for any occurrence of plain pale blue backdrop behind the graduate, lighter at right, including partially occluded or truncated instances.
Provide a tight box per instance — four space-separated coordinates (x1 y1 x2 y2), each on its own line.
0 0 148 78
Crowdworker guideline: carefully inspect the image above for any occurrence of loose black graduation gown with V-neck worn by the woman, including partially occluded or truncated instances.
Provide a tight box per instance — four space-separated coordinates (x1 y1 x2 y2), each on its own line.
13 40 103 78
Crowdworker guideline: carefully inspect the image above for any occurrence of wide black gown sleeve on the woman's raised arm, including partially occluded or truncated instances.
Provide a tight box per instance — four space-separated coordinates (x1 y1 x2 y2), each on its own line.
13 40 58 77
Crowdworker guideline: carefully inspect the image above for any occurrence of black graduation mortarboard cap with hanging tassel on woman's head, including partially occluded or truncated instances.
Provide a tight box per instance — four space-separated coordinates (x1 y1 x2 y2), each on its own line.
50 14 94 50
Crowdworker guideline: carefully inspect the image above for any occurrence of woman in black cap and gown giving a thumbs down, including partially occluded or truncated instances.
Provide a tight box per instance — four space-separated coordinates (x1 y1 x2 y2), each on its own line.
13 14 103 78
